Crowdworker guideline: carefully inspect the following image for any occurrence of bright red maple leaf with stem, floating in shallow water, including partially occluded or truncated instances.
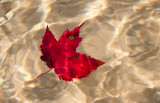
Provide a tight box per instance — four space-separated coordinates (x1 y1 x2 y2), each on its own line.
37 24 104 81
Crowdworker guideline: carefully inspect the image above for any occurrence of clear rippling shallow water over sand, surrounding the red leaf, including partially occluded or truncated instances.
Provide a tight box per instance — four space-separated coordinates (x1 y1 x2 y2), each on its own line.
0 0 160 103
